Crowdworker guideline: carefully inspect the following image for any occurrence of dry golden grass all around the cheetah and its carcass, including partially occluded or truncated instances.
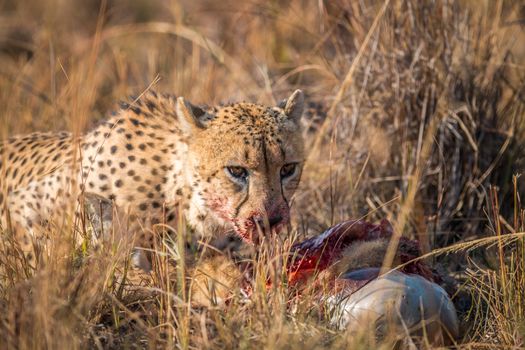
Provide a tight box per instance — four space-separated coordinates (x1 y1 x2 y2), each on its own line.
0 0 525 349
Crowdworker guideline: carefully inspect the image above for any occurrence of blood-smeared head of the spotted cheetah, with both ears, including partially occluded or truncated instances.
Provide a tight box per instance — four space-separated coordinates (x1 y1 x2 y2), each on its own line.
177 90 304 243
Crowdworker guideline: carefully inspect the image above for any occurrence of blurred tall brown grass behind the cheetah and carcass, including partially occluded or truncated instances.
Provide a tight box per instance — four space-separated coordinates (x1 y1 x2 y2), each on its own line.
0 0 525 347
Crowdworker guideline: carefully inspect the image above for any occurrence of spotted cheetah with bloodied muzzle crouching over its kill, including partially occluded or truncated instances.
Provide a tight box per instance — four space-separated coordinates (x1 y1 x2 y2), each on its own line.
0 90 304 269
